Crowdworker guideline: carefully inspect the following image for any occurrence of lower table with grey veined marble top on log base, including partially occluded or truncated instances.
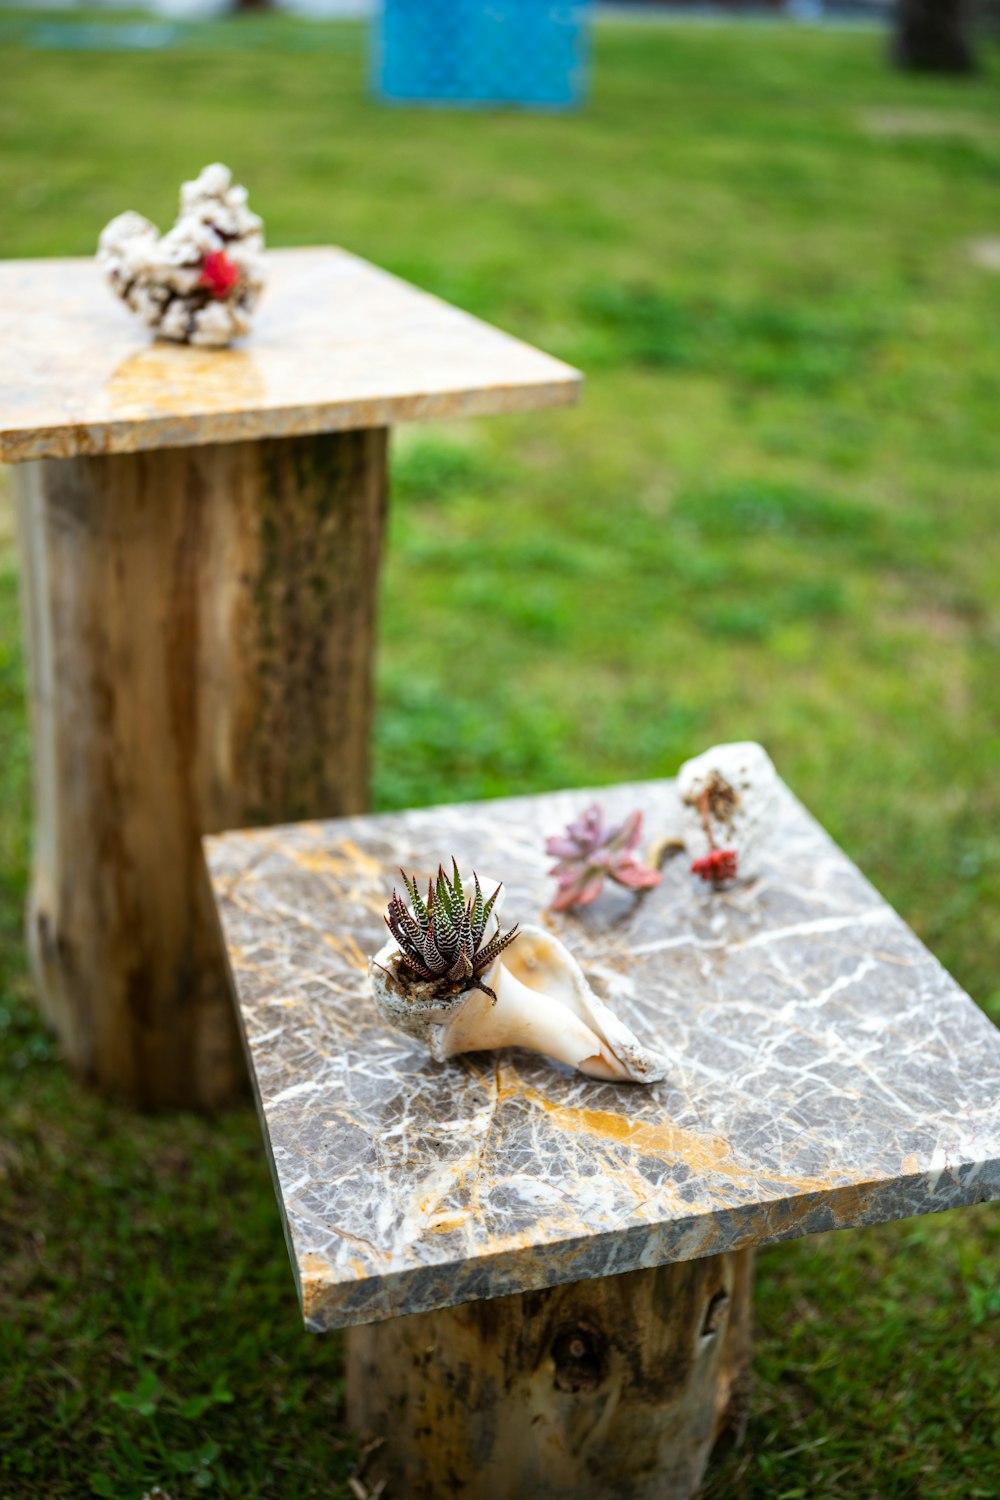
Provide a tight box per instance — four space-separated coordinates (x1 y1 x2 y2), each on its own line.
205 782 1000 1500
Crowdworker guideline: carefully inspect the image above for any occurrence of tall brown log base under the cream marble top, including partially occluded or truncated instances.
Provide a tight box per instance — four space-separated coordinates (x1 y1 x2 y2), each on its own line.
13 431 385 1107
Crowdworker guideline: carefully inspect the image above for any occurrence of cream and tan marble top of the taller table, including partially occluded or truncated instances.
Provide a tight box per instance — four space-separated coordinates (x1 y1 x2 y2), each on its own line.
0 249 580 464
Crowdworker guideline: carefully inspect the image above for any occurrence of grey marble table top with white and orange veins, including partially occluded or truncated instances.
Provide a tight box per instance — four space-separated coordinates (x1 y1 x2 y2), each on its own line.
205 782 1000 1329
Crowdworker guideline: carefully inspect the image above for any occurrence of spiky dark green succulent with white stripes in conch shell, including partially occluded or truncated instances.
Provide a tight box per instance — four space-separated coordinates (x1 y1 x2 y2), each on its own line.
385 855 517 1002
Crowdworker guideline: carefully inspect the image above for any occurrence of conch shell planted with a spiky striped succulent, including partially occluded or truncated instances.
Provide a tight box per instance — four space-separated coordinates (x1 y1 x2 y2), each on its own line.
369 860 666 1083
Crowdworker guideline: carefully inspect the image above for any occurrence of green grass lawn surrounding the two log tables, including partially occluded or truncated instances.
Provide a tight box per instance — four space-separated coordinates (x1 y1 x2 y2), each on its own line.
0 18 1000 1500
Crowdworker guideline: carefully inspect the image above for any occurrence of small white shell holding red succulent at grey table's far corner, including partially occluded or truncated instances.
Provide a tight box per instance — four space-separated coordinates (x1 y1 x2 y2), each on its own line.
678 741 780 887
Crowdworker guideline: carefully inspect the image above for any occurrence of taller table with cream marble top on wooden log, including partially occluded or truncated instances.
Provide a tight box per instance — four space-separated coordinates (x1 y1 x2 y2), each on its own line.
0 251 579 1106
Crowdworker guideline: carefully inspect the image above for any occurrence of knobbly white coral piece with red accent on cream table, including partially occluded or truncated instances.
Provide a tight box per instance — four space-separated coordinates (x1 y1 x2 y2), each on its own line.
97 162 264 348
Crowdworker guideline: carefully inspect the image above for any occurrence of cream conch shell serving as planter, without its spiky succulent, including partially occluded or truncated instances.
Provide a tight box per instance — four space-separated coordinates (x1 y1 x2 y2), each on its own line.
369 893 667 1083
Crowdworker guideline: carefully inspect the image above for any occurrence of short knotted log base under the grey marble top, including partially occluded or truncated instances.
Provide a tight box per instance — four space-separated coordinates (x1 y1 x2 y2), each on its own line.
348 1251 753 1500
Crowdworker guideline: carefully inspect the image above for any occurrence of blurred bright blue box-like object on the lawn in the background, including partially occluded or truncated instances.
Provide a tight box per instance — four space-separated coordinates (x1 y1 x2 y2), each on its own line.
373 0 589 110
